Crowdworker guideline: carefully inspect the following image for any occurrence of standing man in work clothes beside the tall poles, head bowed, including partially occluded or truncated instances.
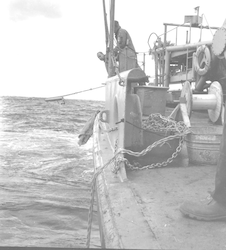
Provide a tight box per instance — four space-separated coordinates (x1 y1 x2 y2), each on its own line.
114 21 139 72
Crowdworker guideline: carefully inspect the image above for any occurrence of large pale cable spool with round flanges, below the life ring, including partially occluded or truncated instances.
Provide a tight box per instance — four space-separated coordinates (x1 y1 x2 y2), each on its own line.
181 81 223 123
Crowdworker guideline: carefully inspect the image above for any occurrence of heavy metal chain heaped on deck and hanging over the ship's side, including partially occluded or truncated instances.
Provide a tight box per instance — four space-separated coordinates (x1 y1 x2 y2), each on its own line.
86 114 190 248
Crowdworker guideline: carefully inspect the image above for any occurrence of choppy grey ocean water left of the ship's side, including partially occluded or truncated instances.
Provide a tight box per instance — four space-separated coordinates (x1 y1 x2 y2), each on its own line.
0 97 104 248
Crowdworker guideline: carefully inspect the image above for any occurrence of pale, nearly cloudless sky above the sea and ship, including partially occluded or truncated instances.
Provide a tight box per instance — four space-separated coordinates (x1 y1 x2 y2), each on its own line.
0 0 226 101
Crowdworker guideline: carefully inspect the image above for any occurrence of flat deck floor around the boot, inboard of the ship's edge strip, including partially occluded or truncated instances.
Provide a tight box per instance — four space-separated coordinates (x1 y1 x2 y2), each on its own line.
127 157 218 250
